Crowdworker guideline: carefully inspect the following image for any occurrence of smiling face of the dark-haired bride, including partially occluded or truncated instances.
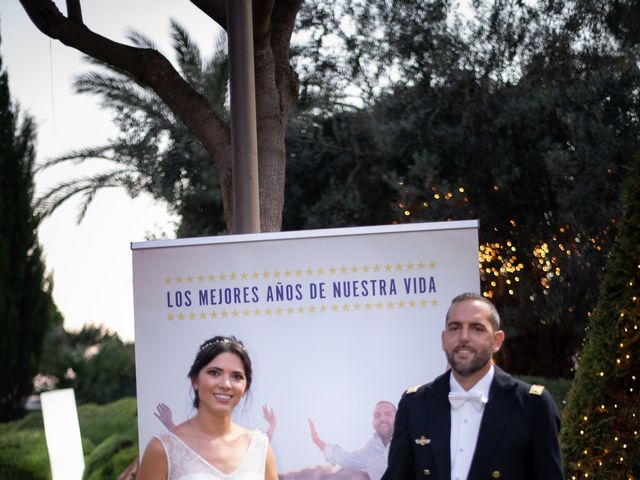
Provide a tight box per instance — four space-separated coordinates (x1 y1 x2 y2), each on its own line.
193 352 247 413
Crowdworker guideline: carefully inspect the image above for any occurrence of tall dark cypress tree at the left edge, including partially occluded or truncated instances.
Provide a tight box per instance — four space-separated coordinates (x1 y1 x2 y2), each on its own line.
0 34 60 421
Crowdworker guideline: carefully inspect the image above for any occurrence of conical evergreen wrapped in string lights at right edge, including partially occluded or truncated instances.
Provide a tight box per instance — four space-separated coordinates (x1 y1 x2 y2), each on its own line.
562 157 640 480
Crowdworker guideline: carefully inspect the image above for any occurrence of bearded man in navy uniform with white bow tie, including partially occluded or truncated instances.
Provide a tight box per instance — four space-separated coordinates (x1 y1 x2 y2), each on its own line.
382 293 564 480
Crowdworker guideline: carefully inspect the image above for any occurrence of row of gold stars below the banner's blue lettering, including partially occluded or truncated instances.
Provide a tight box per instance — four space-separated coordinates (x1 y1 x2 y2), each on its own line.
166 299 439 322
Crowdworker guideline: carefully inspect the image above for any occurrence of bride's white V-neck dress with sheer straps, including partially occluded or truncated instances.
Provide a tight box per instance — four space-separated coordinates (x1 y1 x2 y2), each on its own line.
157 430 269 480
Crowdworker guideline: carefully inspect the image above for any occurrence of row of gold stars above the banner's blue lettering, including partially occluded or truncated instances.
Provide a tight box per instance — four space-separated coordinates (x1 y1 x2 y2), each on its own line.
164 260 436 285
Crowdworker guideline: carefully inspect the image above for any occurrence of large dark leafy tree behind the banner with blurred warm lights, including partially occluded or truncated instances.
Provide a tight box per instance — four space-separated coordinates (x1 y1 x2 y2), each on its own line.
285 0 640 376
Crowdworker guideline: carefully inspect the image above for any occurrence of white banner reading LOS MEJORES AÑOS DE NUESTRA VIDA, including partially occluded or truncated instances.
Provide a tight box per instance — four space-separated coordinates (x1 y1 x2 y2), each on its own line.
131 220 480 472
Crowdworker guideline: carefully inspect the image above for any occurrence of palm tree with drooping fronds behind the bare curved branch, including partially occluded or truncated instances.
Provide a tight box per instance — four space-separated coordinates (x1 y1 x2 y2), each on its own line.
39 20 229 237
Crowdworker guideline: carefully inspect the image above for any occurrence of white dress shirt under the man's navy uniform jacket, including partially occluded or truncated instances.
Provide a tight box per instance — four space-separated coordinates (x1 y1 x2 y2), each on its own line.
449 365 494 480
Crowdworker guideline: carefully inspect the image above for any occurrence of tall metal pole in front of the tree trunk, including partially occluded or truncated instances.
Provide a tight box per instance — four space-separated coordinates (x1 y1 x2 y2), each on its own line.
226 0 260 233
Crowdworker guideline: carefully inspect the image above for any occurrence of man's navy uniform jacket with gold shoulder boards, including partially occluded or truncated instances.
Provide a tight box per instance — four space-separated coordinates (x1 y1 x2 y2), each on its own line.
382 367 564 480
